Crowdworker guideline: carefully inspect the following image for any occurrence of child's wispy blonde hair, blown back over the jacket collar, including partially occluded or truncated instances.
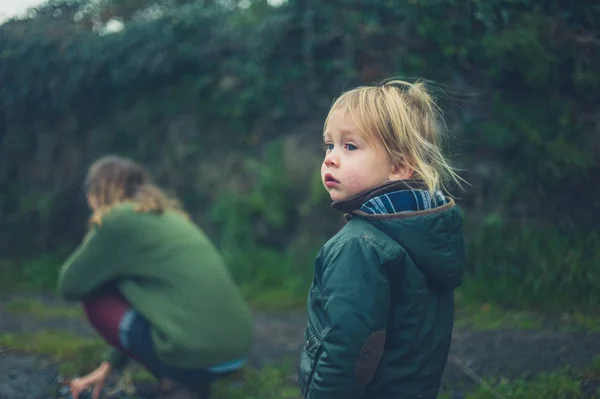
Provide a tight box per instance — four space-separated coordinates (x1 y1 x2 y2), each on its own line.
325 80 462 193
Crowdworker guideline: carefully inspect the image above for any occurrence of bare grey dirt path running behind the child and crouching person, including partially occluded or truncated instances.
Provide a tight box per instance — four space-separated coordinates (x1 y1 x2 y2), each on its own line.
0 296 600 399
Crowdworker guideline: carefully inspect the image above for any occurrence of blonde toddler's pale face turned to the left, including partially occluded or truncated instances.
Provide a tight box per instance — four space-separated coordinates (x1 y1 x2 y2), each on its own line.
321 109 405 201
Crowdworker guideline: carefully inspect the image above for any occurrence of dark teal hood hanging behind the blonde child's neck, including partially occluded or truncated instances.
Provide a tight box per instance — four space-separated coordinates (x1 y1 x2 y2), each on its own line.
332 181 465 290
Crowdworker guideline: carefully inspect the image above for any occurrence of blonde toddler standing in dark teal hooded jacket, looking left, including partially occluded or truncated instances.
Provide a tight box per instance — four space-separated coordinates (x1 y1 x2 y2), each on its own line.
298 81 465 399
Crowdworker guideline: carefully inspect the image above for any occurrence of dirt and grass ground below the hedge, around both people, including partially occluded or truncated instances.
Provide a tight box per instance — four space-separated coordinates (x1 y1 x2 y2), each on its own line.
0 294 600 399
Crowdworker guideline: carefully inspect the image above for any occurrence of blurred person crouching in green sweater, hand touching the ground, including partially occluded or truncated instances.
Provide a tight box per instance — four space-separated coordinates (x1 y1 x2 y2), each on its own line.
58 156 252 399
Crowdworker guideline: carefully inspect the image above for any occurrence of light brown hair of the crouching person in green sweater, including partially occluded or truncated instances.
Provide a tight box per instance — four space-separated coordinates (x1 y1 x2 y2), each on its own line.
85 155 183 225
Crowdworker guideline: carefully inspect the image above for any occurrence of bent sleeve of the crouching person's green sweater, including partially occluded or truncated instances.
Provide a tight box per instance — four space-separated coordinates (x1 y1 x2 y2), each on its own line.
58 220 127 301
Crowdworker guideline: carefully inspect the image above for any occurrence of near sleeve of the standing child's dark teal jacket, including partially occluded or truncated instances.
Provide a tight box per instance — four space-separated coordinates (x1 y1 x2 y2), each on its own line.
306 237 390 399
